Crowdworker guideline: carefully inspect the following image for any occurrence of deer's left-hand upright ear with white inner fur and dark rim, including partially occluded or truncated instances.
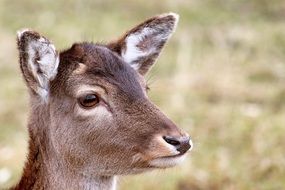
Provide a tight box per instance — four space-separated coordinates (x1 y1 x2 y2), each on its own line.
17 29 59 100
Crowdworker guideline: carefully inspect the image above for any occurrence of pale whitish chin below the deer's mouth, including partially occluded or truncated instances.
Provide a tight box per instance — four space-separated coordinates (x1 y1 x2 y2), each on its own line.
149 154 186 168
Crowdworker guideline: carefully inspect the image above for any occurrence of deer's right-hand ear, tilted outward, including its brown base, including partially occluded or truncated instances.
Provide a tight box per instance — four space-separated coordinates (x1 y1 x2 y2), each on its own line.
107 13 179 75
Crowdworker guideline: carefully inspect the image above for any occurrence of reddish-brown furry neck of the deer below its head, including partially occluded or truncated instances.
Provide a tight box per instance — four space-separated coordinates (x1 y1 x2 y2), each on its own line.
13 102 116 190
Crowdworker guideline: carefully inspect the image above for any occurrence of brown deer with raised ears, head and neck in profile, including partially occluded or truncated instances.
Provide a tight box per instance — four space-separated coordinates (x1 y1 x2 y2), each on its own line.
11 13 193 190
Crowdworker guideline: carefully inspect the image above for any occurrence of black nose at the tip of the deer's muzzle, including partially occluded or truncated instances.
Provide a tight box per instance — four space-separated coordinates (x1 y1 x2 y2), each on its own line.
163 136 191 154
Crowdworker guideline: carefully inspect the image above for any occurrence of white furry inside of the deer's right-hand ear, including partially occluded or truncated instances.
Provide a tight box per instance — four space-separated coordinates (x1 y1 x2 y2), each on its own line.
121 13 179 70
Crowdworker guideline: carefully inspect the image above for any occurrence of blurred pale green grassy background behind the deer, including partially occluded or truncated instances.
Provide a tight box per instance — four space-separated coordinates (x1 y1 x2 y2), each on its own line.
0 0 285 190
